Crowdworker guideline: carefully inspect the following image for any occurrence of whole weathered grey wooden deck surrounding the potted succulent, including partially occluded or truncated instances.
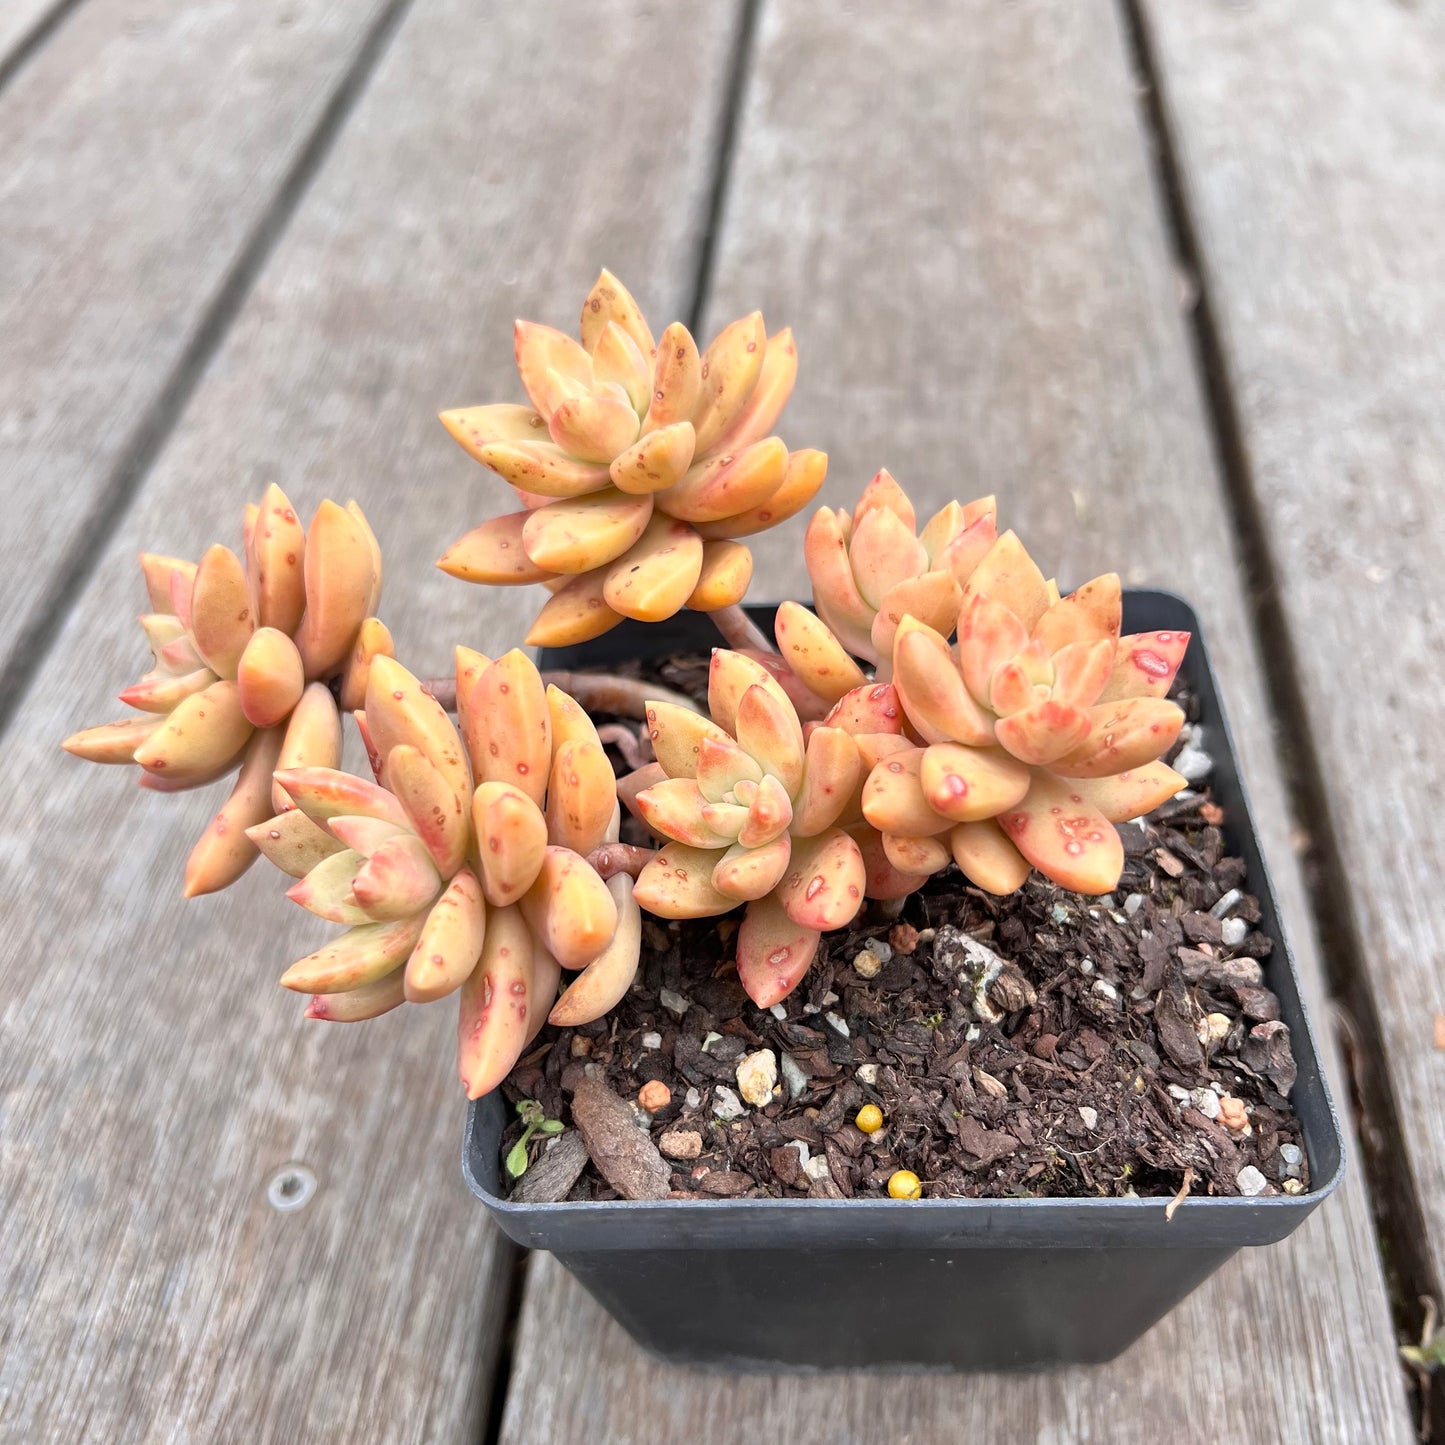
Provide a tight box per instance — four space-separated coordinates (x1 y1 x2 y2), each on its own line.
0 0 1445 1445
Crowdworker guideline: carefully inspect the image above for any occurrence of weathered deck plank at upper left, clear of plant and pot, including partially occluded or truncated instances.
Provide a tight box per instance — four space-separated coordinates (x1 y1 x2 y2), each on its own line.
0 0 407 693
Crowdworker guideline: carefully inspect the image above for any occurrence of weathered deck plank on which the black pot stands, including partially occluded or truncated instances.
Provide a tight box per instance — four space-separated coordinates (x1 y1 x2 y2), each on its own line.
503 0 1409 1445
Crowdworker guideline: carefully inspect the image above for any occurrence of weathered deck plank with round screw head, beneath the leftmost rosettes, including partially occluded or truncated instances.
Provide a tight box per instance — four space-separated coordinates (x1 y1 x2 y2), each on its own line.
0 0 737 1445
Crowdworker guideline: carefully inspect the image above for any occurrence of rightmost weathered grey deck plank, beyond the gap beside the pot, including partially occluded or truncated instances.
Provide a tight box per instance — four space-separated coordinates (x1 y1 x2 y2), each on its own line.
1146 0 1445 1300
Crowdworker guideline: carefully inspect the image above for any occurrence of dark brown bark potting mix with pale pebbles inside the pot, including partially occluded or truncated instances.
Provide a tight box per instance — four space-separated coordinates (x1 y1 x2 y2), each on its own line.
503 660 1309 1199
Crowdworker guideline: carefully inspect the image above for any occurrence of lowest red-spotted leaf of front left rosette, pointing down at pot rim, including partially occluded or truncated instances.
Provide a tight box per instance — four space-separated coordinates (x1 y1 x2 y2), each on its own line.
457 907 533 1098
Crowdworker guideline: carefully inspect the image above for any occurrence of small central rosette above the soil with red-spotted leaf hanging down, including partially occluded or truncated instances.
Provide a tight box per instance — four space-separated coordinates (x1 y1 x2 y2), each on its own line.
633 649 867 1007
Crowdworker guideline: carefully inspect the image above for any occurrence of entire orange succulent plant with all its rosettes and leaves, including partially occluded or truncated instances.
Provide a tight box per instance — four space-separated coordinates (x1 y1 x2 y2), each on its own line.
65 272 1189 1098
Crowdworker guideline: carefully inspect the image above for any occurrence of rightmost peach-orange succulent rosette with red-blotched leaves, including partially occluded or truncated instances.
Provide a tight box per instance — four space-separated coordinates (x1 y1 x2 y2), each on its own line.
863 532 1189 893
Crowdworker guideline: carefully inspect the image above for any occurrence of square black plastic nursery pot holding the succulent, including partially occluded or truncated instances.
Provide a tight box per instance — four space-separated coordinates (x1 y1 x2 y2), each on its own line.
462 591 1344 1370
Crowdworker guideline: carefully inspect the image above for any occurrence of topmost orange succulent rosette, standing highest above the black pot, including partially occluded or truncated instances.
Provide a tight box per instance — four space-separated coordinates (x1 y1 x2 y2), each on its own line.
438 270 827 646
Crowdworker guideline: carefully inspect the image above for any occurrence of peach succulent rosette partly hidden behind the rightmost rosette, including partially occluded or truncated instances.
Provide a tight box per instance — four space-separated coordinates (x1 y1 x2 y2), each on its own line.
776 471 997 704
